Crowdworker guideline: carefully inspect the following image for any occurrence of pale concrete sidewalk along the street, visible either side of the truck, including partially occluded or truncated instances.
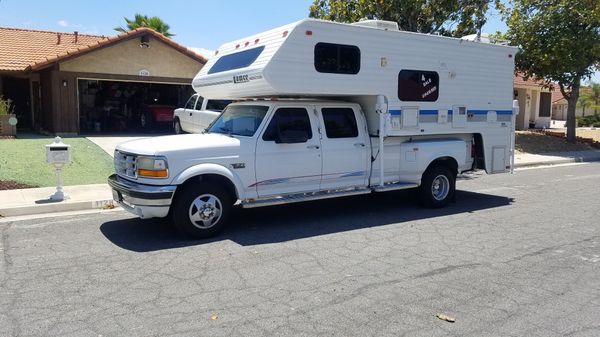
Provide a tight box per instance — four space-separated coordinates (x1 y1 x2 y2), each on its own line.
0 150 600 217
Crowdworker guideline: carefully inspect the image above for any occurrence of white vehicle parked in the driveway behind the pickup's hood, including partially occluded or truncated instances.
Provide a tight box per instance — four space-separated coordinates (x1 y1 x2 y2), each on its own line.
173 94 231 134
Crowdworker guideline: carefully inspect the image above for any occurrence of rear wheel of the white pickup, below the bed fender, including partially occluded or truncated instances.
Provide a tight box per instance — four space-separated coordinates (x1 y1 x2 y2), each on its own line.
419 166 456 208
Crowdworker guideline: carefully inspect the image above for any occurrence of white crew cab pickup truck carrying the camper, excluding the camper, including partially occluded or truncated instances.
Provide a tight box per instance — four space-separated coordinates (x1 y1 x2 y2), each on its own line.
108 100 476 237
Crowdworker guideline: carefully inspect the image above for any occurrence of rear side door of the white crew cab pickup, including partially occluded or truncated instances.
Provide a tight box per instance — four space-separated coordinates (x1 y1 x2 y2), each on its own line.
317 105 370 190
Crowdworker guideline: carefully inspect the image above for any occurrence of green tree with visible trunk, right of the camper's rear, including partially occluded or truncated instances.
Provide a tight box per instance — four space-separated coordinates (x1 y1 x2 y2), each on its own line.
504 0 600 143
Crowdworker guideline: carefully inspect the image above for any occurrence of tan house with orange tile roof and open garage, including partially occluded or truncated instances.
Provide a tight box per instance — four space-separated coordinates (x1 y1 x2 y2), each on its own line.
0 28 206 134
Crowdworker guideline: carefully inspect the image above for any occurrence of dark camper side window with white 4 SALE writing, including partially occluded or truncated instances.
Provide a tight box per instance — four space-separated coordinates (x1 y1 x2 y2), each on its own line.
398 70 440 102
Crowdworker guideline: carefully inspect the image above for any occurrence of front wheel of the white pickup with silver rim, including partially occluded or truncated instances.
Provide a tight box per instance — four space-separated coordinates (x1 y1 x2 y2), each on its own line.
173 182 233 239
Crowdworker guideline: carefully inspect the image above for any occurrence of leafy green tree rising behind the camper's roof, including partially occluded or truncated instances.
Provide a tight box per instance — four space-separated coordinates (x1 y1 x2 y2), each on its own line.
309 0 502 37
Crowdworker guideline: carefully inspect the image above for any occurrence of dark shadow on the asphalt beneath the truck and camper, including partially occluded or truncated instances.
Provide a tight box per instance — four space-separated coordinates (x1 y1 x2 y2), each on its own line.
100 191 513 252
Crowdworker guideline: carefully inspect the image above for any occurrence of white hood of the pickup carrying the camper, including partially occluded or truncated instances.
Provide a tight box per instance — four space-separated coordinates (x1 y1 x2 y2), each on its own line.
117 133 240 157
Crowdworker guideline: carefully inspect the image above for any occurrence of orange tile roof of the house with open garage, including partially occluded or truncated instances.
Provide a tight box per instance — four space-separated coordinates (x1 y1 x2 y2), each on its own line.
0 27 206 71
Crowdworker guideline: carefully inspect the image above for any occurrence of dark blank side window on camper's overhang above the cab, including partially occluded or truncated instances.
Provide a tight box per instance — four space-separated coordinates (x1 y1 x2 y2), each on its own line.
315 42 360 75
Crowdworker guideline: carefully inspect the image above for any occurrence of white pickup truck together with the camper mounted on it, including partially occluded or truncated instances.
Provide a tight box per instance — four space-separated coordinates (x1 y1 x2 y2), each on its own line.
109 19 518 237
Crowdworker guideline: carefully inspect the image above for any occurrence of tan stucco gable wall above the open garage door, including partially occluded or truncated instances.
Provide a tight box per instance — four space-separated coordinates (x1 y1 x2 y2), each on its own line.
60 37 202 79
